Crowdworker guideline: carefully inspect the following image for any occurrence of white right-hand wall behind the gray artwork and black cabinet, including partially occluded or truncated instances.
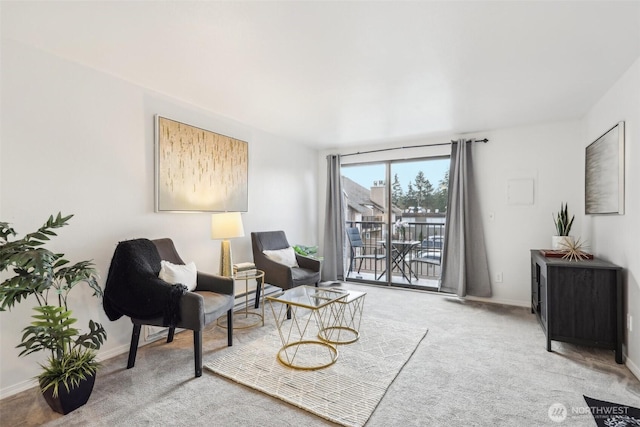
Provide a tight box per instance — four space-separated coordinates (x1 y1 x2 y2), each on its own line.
581 58 640 378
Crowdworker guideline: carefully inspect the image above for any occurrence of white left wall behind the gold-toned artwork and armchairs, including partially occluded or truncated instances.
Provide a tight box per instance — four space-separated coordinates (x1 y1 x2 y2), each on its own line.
0 39 318 398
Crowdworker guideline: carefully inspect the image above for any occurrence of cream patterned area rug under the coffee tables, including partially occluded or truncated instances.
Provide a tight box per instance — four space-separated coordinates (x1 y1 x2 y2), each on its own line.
205 314 427 426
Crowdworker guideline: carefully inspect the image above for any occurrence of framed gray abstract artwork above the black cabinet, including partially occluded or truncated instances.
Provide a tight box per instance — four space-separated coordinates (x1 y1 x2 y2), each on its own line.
584 122 624 215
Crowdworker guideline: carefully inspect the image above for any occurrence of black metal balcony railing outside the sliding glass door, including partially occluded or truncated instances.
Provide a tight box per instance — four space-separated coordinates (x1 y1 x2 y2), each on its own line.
346 218 445 286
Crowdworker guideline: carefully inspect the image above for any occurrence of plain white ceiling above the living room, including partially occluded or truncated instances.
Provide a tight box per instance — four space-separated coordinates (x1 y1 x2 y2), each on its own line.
0 1 640 149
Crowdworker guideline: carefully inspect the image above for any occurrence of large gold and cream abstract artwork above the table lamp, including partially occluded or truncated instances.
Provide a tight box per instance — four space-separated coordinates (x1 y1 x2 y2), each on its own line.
155 115 249 212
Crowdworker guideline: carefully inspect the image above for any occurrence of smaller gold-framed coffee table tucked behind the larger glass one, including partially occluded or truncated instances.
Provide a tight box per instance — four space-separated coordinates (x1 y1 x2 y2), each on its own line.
318 290 367 344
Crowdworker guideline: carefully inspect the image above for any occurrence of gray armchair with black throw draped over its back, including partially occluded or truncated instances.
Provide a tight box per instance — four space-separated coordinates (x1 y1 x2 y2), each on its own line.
103 239 235 377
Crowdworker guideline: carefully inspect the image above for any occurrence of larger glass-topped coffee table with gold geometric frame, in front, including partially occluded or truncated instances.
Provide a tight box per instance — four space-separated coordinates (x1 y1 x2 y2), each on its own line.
266 286 348 370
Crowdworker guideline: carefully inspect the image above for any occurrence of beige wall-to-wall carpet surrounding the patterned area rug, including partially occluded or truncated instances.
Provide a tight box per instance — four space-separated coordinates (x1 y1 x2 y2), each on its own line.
0 283 640 427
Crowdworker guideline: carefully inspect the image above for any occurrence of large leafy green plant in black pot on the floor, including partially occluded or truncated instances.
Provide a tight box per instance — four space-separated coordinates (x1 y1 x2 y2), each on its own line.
0 213 107 414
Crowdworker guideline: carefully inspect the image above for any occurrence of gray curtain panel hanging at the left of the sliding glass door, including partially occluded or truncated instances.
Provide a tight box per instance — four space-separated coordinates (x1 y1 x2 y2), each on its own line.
322 154 345 280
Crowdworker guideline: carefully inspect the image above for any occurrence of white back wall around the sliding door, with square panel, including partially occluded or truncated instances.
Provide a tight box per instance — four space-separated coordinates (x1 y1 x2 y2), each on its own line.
319 121 584 306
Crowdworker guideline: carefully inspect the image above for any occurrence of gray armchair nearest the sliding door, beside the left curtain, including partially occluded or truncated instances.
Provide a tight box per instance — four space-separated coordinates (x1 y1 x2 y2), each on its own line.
251 231 321 308
